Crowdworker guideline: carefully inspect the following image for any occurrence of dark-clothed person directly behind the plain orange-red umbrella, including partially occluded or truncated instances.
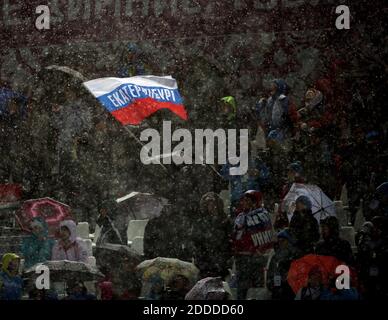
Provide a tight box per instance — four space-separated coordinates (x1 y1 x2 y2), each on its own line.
315 217 354 266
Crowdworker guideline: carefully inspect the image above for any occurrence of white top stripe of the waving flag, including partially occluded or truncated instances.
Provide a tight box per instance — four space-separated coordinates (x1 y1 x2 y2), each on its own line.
84 76 178 97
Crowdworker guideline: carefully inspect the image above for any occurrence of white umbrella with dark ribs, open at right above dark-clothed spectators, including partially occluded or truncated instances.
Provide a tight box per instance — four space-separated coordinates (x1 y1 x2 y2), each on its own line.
282 183 336 223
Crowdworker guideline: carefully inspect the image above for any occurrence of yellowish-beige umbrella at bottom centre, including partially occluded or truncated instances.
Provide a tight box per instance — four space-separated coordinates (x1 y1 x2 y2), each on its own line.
136 257 199 285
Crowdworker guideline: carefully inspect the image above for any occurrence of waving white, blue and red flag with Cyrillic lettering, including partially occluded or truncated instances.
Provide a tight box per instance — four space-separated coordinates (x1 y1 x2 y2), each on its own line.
84 76 187 125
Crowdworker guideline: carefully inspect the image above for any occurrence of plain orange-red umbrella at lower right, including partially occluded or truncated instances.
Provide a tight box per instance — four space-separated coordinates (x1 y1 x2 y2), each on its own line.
287 254 356 294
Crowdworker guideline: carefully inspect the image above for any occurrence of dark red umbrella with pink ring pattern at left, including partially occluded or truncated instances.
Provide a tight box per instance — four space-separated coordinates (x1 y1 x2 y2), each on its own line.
16 198 73 236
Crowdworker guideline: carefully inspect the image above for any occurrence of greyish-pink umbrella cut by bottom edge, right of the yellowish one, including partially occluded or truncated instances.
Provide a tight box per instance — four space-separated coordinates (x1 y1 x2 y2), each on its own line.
185 277 228 300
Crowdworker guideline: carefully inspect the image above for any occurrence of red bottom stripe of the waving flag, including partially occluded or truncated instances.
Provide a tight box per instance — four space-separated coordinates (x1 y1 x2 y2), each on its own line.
112 98 187 125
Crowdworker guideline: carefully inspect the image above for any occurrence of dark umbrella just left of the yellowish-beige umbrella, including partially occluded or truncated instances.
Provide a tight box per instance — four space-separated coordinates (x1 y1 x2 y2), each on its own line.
95 243 143 270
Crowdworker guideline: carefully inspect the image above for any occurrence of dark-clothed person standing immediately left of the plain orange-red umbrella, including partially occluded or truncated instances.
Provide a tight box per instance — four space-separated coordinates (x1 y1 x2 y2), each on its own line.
267 229 300 300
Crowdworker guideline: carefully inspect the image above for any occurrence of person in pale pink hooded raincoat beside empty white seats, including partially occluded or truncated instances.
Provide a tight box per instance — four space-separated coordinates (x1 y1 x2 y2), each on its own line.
52 220 88 263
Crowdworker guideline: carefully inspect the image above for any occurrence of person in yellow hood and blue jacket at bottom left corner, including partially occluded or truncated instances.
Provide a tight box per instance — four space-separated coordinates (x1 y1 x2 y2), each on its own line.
0 253 23 300
